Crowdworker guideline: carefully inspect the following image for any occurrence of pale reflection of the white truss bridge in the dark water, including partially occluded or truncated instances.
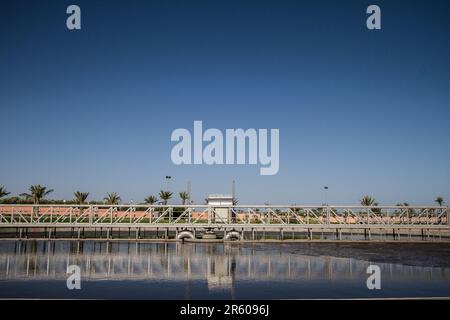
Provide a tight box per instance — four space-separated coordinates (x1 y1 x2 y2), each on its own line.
0 241 450 299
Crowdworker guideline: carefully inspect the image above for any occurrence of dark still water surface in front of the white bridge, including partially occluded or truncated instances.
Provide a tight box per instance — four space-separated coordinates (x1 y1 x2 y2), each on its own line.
0 240 450 299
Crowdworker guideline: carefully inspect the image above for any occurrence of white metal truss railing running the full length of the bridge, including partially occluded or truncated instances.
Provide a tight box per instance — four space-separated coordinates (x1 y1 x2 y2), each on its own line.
0 205 450 227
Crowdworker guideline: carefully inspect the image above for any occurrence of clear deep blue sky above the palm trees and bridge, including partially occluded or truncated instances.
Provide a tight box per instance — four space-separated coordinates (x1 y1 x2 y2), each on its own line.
0 0 450 204
